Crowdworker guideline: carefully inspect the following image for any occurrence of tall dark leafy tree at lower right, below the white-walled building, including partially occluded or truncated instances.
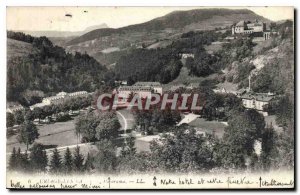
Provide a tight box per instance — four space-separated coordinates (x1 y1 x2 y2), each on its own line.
220 110 264 169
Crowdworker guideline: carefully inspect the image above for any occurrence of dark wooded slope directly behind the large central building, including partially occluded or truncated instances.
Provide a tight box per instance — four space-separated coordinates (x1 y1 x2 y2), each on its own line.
115 49 182 83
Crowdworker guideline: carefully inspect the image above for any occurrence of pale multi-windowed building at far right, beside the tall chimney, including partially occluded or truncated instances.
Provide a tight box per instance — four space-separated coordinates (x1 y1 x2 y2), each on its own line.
240 92 275 116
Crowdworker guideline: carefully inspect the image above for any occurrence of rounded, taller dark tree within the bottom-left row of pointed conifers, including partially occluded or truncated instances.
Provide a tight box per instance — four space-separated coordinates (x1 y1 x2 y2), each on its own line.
29 143 48 172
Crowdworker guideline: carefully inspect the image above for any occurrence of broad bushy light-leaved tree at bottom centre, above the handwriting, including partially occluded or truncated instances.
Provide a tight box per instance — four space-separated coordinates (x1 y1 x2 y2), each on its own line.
150 126 214 172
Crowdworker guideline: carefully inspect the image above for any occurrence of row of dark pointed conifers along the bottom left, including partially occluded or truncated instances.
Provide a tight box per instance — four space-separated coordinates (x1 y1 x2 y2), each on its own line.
9 143 89 175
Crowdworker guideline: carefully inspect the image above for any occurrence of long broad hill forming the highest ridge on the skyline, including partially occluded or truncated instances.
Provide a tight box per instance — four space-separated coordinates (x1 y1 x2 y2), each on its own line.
67 9 270 45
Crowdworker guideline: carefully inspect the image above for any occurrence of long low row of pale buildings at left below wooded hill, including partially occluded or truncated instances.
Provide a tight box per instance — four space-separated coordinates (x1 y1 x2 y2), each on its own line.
30 91 88 110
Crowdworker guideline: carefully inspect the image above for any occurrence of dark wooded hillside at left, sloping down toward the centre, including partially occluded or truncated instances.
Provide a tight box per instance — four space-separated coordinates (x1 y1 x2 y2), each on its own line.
7 31 107 102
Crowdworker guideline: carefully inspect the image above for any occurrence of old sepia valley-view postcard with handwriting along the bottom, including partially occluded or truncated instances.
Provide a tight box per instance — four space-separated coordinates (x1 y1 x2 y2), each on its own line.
6 6 295 190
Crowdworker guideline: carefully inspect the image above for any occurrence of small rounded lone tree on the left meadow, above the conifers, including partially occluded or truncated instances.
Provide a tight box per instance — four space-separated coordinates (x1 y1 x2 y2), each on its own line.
18 121 39 150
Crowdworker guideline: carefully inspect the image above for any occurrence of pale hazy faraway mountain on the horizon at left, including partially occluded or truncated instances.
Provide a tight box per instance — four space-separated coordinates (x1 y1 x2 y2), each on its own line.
21 23 108 37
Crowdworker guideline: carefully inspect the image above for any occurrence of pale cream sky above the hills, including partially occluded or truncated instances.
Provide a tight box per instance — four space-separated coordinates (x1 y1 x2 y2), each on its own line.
6 7 294 31
